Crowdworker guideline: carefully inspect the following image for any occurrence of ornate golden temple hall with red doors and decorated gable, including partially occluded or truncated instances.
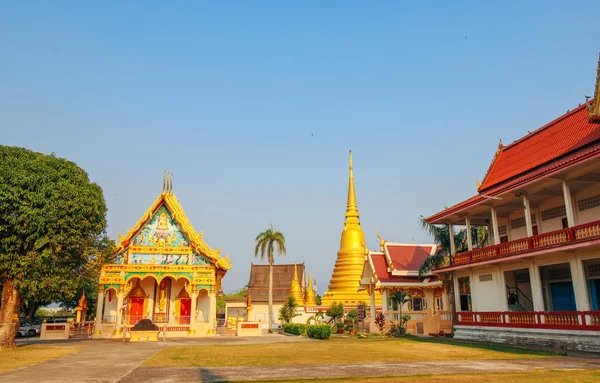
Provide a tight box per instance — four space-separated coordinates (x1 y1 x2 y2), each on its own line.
94 175 231 338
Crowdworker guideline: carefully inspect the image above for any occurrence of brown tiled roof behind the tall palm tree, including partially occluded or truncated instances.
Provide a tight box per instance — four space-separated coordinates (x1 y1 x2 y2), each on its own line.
248 263 304 303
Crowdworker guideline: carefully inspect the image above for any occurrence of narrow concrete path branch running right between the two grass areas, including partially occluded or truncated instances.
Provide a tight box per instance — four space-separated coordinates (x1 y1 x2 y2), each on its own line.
119 357 600 383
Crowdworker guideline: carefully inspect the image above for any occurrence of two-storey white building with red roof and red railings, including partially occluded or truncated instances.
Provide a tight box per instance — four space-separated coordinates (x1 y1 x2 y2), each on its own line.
426 55 600 352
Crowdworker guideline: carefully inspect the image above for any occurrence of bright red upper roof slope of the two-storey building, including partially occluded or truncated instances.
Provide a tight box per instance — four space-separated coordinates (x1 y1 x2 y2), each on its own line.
479 103 600 191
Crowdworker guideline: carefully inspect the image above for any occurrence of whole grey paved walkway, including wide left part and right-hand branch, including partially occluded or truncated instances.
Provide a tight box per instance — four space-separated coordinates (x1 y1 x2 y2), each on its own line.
0 340 600 383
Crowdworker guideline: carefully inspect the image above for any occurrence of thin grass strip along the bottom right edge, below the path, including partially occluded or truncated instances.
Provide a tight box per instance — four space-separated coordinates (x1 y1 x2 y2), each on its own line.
238 370 600 383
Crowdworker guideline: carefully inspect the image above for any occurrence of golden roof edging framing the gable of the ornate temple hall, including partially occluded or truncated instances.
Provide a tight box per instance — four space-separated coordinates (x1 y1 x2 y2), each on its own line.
115 179 231 270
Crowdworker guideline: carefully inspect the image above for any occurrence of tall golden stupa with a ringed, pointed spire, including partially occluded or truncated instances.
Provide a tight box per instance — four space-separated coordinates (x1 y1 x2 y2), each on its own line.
322 151 381 307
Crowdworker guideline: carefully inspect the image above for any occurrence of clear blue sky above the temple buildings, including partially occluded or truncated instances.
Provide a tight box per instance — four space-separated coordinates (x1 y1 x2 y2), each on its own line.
0 1 600 293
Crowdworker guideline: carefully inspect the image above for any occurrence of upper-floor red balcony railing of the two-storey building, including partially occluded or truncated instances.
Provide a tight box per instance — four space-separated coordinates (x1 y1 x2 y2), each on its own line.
452 221 600 265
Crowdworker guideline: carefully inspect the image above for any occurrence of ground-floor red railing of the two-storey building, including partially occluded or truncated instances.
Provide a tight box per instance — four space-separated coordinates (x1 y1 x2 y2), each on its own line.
456 311 600 331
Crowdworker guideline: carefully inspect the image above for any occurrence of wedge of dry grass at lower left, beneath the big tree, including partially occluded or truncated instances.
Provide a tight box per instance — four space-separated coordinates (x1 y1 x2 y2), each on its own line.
0 346 79 373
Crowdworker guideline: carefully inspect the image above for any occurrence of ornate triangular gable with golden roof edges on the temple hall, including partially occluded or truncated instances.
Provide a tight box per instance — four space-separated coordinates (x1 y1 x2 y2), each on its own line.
115 179 231 270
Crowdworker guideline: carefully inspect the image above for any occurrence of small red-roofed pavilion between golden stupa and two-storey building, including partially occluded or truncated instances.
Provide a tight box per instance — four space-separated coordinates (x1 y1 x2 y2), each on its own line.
360 236 452 335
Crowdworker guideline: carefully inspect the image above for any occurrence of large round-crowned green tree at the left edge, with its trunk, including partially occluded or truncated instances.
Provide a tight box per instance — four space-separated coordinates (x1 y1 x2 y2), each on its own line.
0 146 106 349
